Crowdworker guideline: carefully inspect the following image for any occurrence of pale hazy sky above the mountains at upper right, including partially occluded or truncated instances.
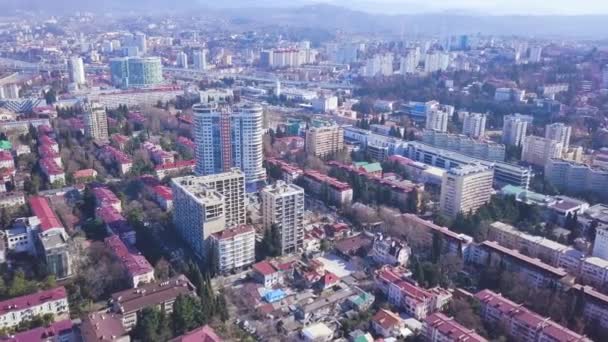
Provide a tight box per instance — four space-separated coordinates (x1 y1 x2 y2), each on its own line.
316 0 608 15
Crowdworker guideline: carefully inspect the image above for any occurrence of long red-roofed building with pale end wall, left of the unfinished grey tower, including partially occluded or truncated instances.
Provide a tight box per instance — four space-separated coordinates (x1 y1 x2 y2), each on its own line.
105 235 154 287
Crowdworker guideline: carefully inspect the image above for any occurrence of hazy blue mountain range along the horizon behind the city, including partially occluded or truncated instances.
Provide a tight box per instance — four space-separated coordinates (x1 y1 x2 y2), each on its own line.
0 0 608 38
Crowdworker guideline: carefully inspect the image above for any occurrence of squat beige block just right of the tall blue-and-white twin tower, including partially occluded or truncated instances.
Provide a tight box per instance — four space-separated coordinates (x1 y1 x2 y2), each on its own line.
305 122 344 158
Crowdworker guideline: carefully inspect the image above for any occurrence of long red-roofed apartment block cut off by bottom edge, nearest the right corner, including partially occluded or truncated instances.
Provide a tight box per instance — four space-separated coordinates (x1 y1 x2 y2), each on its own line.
475 290 591 342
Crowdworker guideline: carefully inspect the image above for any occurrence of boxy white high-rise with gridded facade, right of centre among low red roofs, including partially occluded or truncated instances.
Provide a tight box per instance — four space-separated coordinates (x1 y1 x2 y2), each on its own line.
439 164 494 217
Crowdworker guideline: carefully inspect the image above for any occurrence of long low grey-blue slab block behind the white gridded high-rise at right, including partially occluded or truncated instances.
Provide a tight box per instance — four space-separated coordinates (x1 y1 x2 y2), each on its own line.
422 130 506 161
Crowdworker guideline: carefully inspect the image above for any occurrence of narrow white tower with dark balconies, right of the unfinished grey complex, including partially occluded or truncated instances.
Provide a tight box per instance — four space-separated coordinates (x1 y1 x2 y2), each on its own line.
261 181 304 254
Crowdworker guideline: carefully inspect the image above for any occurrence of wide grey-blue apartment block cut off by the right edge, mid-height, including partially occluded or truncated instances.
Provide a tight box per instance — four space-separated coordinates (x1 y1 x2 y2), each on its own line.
545 158 608 199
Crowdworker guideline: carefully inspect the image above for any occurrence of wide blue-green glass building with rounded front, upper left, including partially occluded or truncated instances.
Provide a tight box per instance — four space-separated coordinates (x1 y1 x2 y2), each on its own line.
110 57 163 88
